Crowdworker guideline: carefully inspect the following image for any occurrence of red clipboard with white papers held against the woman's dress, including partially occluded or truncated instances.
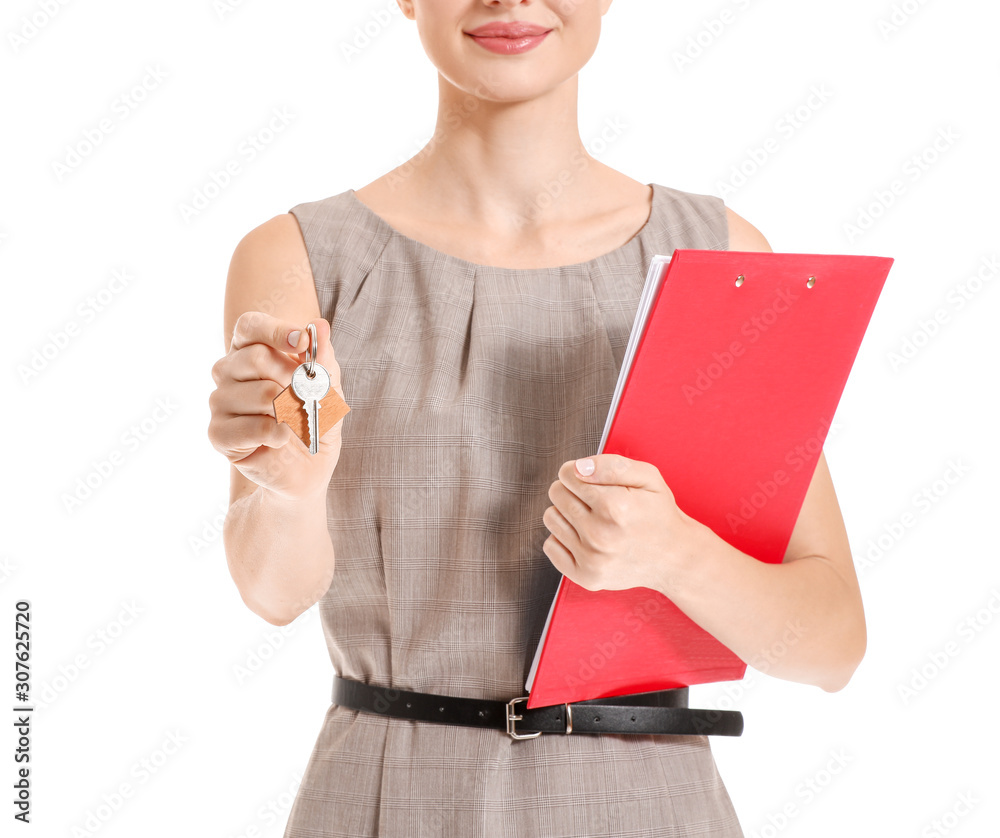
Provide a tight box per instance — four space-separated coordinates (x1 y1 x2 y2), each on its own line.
527 249 893 708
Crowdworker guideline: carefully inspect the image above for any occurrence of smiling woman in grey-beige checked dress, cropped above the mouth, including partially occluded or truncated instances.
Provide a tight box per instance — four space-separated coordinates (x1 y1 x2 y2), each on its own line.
209 0 865 838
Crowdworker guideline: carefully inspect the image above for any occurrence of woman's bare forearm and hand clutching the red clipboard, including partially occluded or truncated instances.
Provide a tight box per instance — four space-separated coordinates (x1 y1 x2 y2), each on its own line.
542 442 867 692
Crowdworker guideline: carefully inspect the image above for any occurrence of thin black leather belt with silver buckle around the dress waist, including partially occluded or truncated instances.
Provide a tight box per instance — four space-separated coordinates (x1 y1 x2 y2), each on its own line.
333 675 743 739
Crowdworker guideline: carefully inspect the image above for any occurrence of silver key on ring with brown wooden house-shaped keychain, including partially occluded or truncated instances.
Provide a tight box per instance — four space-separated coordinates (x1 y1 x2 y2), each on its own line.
271 323 351 454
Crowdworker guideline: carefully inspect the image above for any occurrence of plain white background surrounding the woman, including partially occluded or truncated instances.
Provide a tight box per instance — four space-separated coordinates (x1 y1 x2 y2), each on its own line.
0 0 1000 838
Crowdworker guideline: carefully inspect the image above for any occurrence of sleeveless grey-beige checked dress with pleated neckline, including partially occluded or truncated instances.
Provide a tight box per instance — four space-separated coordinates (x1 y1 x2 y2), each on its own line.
284 184 743 838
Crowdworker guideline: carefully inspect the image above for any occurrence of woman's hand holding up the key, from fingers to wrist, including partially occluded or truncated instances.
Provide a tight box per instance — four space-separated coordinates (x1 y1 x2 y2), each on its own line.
208 311 350 499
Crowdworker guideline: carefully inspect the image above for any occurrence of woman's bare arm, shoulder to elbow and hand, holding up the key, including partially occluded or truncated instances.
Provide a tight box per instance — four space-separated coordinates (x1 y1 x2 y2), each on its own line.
208 213 344 626
